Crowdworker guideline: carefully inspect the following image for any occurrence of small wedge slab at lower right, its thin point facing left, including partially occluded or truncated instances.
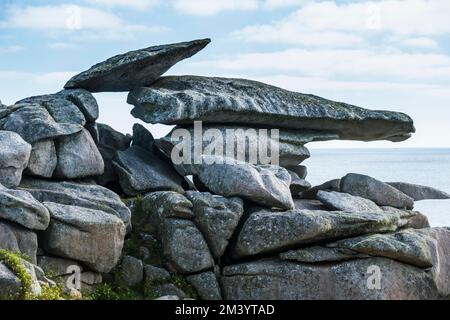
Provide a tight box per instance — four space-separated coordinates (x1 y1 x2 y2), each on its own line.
328 229 437 268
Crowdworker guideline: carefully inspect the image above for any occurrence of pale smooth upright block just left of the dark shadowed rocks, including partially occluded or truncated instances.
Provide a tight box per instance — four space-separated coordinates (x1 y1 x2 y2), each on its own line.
54 129 105 179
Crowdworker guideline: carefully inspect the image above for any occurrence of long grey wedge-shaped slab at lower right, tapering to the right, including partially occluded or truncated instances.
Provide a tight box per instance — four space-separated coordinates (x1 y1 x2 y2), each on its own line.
232 210 418 258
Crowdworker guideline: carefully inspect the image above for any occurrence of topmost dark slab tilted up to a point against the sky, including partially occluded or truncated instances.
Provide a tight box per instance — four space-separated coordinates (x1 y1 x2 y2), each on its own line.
64 39 211 92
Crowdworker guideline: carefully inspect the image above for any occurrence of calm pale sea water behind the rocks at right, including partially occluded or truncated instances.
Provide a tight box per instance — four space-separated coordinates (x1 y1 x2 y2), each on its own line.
304 149 450 227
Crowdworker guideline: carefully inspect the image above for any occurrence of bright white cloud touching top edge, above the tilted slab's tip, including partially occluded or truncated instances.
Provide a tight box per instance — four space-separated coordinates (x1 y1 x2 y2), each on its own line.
172 0 259 16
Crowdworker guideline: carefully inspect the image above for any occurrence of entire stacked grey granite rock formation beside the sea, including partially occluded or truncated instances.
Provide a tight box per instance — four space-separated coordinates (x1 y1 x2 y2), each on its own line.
0 39 450 300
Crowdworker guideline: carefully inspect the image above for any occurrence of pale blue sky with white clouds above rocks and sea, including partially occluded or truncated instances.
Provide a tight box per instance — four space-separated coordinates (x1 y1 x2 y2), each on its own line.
0 0 450 148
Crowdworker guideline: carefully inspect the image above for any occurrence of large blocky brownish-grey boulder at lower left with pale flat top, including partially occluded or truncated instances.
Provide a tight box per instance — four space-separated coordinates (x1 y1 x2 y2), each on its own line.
44 202 125 273
